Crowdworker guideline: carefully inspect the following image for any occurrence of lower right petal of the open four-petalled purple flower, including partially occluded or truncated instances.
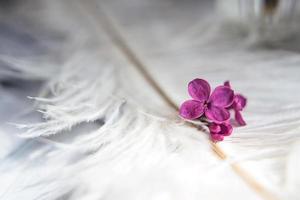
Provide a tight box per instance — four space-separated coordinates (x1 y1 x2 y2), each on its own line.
205 105 230 122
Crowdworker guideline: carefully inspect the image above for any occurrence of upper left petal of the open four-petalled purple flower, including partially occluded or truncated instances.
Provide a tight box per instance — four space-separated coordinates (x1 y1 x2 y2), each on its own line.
188 78 210 101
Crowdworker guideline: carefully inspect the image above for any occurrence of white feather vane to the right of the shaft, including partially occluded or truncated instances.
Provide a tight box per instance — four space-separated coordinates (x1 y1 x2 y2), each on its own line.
98 0 300 199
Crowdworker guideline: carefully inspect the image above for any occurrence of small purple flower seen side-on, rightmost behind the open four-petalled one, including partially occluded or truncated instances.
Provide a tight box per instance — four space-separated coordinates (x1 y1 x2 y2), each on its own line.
224 81 247 126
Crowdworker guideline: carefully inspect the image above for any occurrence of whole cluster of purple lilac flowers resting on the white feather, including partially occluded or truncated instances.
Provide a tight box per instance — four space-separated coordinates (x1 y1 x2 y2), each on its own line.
179 79 247 142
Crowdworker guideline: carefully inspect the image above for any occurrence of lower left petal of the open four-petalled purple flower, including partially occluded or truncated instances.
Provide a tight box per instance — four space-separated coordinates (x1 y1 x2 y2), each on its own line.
179 100 204 119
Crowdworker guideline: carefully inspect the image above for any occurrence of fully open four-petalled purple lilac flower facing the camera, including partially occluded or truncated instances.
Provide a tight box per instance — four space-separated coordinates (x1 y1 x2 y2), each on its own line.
179 79 234 123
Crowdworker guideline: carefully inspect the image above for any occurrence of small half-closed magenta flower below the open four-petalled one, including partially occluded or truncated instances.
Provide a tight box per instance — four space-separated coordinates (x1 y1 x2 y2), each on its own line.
208 122 233 142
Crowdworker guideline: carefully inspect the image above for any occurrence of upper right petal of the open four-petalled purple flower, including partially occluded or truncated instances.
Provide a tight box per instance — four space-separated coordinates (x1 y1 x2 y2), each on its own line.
209 86 234 108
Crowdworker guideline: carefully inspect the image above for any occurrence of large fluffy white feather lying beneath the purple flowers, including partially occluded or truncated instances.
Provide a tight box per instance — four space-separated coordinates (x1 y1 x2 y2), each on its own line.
0 0 300 200
